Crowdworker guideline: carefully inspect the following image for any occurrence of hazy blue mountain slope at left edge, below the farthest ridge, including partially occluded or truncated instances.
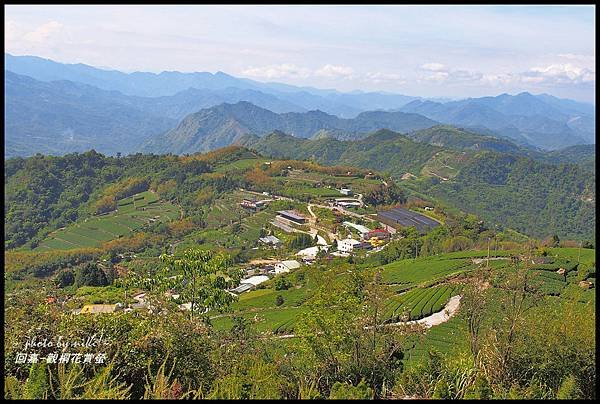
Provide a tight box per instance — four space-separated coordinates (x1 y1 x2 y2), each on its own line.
4 72 177 157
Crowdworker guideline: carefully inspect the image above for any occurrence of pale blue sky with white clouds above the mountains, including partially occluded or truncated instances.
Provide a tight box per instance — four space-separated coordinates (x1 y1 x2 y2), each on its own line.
5 5 596 102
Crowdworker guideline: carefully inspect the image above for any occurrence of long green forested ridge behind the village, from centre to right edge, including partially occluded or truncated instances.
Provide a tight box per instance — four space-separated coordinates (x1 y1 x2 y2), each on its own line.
240 130 596 239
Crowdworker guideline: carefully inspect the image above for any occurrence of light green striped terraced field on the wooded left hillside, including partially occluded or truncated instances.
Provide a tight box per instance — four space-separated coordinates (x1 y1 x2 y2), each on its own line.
34 191 180 251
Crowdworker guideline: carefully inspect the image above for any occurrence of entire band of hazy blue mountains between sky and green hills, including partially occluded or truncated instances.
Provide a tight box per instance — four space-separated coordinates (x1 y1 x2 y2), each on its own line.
5 54 595 157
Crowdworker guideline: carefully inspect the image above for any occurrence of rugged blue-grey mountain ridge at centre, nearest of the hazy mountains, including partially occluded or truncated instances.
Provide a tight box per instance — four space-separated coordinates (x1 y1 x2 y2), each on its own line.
142 101 437 154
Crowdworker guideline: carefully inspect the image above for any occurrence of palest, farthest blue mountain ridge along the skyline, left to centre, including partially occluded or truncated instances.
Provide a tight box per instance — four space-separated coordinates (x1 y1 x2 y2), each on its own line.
4 53 420 118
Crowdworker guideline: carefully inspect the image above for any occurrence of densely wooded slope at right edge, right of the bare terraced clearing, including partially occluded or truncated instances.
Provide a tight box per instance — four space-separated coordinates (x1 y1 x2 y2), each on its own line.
421 152 596 239
